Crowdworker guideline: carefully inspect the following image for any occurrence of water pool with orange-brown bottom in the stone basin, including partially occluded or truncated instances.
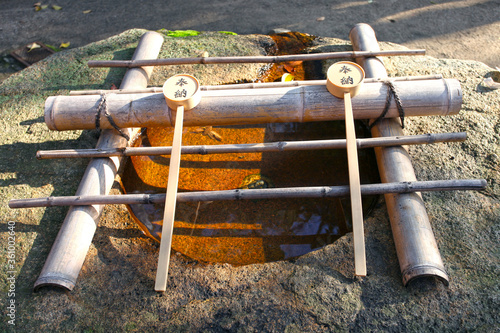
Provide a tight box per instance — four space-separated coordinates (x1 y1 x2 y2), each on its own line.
122 122 379 265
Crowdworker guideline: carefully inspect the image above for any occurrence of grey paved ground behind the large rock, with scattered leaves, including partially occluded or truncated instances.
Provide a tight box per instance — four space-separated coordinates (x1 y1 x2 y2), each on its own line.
0 0 500 79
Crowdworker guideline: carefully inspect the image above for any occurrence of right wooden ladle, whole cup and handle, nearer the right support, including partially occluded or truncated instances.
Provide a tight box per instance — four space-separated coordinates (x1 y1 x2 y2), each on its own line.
326 61 366 276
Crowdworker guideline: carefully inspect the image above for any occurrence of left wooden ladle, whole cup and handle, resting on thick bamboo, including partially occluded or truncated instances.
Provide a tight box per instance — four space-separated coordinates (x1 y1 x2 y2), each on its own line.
155 74 201 291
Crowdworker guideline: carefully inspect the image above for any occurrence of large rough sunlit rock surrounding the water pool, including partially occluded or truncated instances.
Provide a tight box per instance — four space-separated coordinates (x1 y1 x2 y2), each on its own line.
0 27 500 332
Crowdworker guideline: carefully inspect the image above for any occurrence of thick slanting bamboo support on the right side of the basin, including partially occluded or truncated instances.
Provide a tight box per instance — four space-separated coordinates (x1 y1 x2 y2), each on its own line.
349 24 448 285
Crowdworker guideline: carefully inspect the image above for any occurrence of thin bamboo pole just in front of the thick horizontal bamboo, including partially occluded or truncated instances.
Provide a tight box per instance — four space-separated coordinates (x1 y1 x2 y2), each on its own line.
36 132 467 160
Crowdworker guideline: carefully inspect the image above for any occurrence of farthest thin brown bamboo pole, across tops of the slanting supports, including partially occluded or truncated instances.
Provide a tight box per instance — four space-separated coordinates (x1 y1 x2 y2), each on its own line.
88 50 425 68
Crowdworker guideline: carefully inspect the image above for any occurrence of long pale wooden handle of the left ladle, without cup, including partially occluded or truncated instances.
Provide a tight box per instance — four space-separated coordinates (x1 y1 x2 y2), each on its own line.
155 106 184 291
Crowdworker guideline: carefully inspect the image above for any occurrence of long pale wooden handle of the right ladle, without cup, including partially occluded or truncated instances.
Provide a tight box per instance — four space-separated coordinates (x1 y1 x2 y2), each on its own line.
344 92 366 276
